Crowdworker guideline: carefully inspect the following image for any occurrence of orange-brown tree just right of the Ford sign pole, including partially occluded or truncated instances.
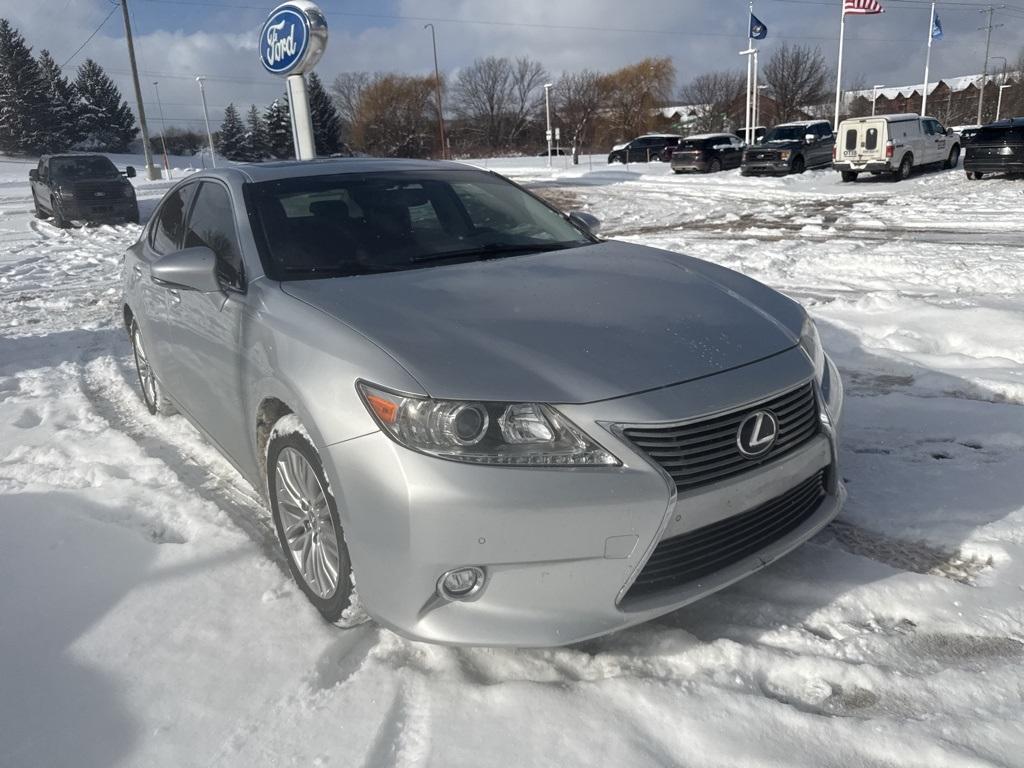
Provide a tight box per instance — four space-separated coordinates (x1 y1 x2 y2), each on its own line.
351 75 436 158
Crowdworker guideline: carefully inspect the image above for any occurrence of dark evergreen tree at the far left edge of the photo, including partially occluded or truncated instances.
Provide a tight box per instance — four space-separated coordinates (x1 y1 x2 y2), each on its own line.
0 18 48 153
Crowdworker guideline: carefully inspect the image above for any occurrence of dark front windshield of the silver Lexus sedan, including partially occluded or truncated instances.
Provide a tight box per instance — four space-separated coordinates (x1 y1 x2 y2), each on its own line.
250 170 594 281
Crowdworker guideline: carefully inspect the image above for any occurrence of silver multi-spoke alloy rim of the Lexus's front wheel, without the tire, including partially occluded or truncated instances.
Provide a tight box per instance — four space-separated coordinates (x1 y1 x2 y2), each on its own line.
274 446 341 599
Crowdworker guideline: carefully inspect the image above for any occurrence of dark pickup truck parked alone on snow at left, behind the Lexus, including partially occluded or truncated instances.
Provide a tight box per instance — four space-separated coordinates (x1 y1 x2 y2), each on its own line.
29 154 138 228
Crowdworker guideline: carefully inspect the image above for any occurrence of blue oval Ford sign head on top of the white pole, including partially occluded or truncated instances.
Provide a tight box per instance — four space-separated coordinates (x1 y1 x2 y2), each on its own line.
259 0 327 75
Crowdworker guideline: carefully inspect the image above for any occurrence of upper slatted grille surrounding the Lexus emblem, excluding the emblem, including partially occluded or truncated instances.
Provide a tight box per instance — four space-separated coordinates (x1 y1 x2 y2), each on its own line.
623 383 820 490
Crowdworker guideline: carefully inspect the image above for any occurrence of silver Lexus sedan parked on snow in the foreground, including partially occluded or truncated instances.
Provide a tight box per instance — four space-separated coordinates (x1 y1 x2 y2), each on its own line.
123 159 845 646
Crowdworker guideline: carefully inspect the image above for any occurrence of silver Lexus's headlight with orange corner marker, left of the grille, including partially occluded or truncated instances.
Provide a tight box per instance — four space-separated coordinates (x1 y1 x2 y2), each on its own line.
358 382 621 467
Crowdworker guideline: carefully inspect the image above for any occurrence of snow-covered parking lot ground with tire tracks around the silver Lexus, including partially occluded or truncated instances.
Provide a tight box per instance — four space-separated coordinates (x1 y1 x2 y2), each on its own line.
0 158 1024 768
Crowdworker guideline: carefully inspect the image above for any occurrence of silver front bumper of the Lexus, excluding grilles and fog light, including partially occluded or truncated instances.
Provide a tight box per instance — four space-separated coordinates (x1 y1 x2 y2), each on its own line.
325 349 845 646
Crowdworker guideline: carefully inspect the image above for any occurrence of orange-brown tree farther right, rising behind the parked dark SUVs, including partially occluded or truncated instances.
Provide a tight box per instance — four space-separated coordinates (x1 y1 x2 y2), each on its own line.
602 56 676 140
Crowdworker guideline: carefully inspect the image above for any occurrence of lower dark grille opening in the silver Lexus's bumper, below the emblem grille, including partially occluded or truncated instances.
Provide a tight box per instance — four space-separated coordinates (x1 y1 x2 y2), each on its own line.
624 469 827 600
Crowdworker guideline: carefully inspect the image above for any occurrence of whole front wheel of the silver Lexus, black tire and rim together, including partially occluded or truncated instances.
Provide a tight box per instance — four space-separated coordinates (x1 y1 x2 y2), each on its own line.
266 432 352 624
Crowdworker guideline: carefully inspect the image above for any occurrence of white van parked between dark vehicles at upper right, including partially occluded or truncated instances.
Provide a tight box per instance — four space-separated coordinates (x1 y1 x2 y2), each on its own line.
833 115 961 181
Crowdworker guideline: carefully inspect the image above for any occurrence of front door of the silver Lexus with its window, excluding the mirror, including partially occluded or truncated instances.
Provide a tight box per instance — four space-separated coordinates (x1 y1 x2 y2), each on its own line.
168 180 249 464
